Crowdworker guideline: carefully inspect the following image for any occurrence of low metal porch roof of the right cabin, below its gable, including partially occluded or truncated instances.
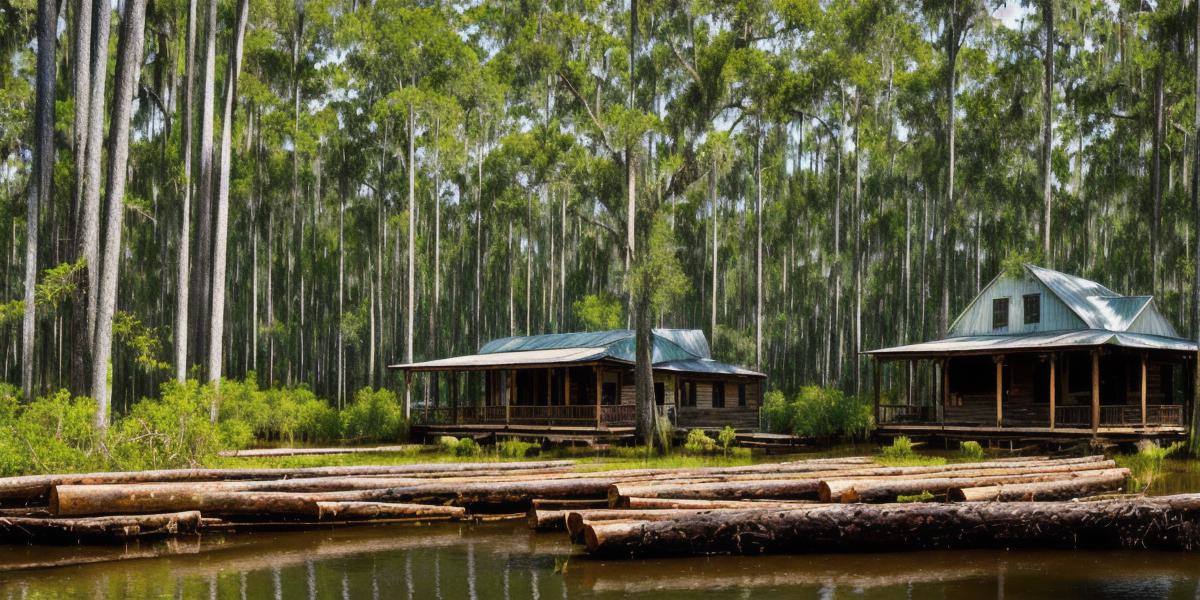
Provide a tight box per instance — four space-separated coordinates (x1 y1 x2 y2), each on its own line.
865 329 1196 356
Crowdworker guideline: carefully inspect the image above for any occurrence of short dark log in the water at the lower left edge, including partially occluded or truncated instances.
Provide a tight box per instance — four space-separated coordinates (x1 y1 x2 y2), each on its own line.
0 510 200 544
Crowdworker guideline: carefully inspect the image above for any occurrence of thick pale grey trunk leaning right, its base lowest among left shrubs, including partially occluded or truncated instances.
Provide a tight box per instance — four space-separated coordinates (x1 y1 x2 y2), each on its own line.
91 0 146 432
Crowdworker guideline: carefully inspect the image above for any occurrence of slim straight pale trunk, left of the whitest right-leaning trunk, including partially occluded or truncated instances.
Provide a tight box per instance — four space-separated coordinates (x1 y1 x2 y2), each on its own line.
174 0 198 383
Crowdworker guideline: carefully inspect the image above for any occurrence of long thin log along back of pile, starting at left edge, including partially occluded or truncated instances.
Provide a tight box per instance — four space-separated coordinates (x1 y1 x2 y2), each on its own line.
0 461 575 504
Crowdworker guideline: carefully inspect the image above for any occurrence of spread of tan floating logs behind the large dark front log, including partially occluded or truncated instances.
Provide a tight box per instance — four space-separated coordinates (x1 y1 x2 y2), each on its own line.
0 456 1142 556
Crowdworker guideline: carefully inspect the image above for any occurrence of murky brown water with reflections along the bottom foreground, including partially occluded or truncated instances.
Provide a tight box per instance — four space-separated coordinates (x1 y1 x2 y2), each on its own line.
0 523 1200 600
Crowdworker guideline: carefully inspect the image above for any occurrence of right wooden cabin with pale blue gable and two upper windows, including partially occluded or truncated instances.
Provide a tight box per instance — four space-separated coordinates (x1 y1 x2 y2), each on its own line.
866 265 1196 442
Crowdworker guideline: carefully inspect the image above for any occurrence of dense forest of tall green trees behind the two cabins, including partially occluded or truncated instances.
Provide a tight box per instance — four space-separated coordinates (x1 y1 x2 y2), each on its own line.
0 0 1200 432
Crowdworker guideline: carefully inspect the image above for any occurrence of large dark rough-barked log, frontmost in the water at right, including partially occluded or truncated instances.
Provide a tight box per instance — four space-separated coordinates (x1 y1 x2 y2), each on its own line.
583 494 1200 558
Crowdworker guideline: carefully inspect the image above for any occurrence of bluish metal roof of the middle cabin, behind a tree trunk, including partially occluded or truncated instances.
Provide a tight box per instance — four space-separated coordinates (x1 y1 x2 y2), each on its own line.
391 329 766 377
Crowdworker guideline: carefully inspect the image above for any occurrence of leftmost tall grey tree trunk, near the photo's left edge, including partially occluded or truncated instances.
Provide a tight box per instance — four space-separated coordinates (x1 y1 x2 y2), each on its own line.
20 1 59 400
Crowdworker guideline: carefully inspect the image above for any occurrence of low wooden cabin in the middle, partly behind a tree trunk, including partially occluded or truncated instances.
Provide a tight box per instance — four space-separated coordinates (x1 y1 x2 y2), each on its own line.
391 329 766 439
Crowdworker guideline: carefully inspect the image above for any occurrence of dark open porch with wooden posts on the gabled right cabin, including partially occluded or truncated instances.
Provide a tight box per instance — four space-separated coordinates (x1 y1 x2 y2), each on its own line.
875 347 1193 440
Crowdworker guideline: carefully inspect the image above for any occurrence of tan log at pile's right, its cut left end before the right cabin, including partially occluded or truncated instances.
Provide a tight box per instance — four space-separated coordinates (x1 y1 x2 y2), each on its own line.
818 469 1129 503
